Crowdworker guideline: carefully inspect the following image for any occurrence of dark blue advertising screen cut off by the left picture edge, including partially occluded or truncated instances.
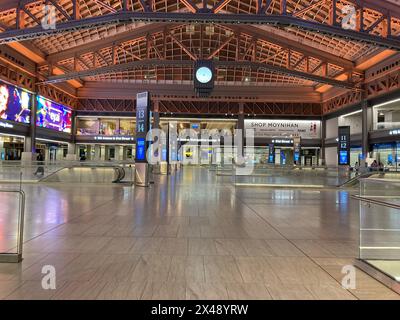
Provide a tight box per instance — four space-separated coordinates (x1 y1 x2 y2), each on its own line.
0 82 32 123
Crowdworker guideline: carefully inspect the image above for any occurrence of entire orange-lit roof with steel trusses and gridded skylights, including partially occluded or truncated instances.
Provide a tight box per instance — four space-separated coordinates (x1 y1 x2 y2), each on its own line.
0 0 400 114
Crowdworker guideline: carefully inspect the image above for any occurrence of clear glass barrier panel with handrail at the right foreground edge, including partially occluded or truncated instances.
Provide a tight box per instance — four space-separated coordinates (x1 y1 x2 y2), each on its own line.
353 177 400 281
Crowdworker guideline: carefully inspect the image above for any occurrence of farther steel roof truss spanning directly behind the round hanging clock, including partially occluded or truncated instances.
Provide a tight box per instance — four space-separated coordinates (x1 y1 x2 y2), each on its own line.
40 24 362 88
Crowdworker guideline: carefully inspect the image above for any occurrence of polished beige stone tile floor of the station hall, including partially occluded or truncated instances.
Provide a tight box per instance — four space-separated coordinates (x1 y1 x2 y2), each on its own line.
0 168 400 299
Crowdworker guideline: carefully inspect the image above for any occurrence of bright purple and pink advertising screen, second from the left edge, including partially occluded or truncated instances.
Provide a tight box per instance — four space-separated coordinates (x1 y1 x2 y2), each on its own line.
36 96 72 133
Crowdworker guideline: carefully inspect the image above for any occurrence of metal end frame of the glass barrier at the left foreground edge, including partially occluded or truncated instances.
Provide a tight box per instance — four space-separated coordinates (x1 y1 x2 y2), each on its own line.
0 190 25 263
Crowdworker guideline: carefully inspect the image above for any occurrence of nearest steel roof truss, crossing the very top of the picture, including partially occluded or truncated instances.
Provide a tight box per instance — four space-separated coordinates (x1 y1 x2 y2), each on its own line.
0 0 400 49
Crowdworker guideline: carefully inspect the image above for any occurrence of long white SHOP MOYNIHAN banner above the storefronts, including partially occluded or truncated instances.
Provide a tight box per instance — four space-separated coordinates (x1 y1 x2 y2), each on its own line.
244 119 321 139
